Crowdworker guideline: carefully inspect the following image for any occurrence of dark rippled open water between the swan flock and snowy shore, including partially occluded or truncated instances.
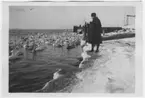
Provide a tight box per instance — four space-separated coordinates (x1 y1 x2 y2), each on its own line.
9 46 81 92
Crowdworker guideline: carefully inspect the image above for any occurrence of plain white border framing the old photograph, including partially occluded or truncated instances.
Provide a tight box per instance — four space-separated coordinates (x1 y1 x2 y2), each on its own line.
2 1 143 97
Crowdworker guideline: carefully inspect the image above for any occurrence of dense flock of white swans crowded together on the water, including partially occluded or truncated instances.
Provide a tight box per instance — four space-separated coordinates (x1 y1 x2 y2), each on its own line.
9 32 81 58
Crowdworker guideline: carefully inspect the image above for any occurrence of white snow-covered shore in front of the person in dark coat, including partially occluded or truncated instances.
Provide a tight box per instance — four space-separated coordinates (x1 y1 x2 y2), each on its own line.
71 38 135 93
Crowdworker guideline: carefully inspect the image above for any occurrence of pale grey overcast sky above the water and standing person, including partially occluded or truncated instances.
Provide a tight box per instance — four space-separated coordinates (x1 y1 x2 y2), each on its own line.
9 6 135 29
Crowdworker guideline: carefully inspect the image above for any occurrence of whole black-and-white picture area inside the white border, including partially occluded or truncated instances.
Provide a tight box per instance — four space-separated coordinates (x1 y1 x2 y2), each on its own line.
0 2 142 94
